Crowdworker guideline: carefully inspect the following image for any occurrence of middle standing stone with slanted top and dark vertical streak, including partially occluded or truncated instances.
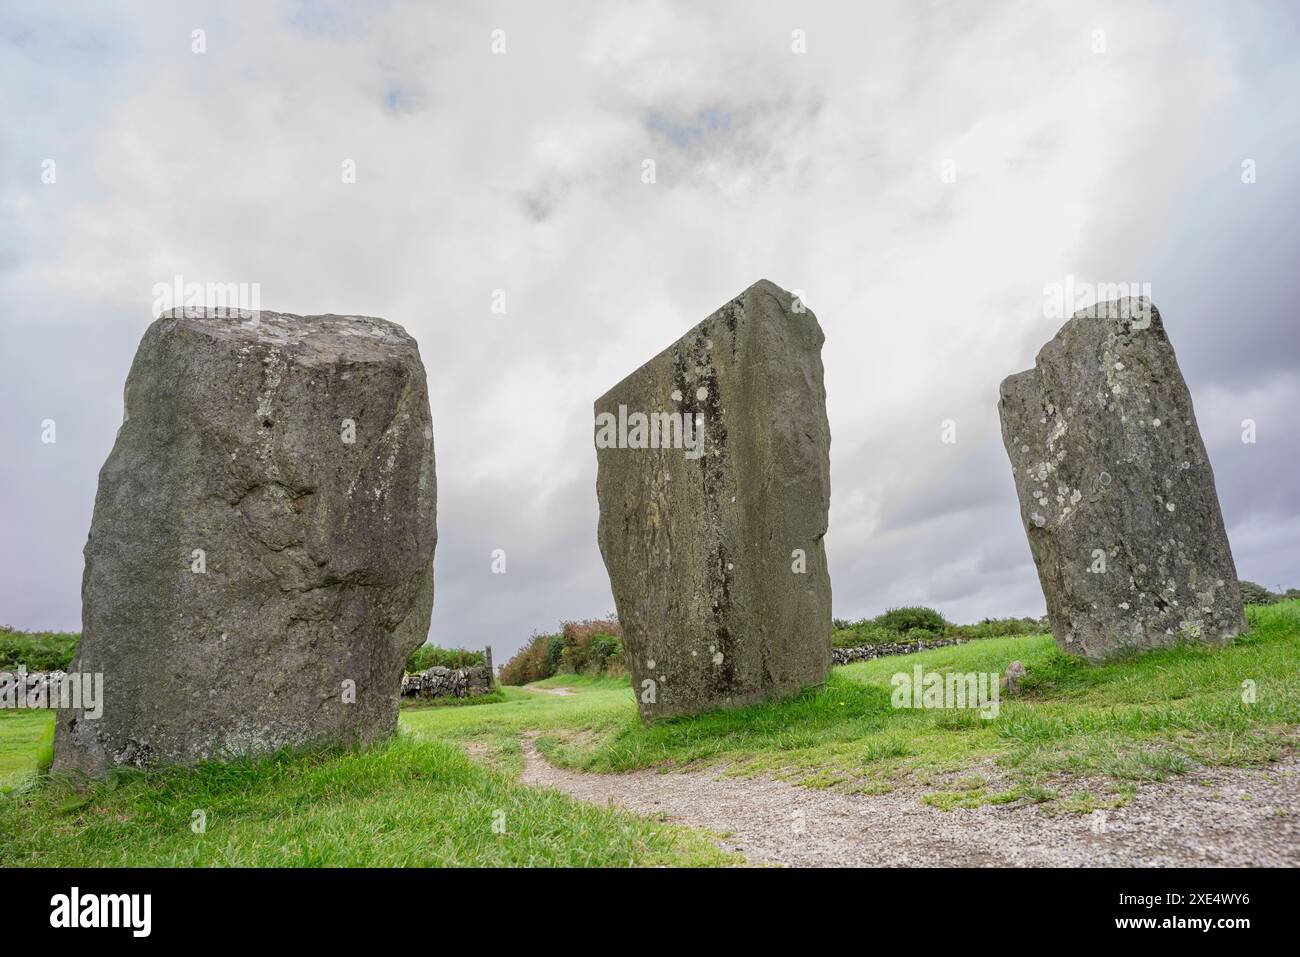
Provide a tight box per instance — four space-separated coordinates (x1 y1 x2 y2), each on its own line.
595 281 831 720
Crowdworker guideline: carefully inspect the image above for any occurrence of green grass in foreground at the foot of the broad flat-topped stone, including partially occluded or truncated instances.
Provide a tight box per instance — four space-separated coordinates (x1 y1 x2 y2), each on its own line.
0 728 732 867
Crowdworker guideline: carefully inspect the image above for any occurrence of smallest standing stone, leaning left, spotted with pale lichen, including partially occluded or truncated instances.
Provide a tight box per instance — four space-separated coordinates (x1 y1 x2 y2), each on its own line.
998 299 1245 662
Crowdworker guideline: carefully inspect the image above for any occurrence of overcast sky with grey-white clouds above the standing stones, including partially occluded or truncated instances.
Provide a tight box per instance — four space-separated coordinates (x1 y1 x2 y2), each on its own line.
0 0 1300 661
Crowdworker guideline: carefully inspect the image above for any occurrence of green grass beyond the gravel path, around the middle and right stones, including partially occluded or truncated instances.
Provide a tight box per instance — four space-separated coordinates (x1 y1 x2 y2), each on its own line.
408 602 1300 804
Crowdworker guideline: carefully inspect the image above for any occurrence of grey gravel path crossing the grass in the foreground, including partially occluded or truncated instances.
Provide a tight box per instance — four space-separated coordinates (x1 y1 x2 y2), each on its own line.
523 740 1300 867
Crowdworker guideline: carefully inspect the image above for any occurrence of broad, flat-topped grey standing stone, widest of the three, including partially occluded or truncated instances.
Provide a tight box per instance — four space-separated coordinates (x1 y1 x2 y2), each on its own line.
55 309 437 776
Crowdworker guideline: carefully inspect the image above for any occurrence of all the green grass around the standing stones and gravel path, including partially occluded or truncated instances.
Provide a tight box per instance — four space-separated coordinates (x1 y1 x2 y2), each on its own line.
0 601 1300 866
